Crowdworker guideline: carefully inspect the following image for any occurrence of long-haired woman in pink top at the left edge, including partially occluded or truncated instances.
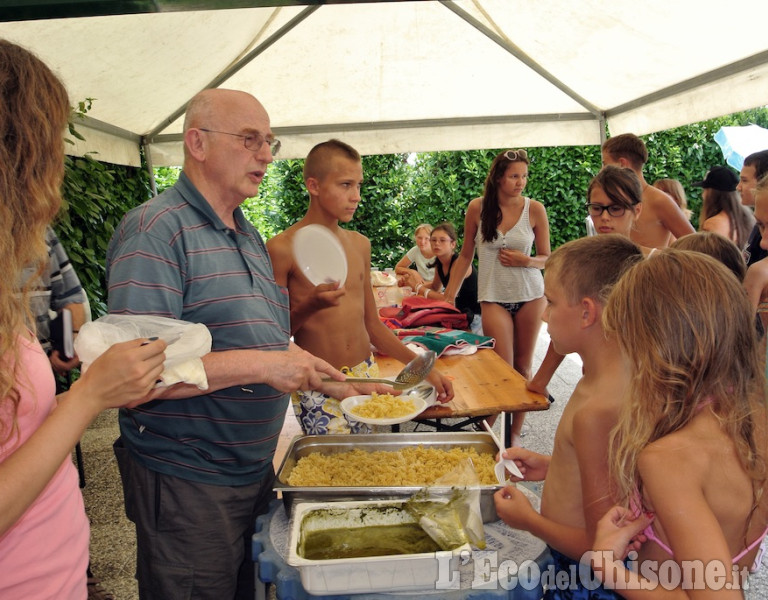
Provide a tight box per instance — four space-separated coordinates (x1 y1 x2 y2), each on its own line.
0 40 165 600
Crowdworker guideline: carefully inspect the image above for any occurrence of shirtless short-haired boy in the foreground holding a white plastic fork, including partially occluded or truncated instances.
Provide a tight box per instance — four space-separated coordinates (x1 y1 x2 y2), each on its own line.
494 234 643 598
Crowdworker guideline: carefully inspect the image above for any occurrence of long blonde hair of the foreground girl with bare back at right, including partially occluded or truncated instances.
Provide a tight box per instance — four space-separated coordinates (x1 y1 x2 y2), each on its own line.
603 249 767 511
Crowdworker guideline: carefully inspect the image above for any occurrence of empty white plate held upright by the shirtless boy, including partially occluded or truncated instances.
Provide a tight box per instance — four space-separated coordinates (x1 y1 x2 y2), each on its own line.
293 225 347 286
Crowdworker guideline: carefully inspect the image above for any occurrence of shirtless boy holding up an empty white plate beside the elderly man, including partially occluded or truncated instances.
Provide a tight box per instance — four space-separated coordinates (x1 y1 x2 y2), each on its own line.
267 140 453 434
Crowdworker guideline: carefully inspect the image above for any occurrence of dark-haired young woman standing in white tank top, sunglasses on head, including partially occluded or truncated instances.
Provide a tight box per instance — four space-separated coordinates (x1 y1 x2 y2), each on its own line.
446 150 550 445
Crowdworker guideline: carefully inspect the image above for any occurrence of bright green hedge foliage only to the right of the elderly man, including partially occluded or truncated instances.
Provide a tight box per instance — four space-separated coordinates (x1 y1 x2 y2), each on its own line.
245 108 768 268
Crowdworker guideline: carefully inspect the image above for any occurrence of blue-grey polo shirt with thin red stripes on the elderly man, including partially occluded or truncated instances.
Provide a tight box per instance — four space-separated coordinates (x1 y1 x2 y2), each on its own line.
107 173 290 485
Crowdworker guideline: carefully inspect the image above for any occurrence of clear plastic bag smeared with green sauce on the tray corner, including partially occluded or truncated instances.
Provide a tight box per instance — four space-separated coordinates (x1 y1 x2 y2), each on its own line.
405 458 485 550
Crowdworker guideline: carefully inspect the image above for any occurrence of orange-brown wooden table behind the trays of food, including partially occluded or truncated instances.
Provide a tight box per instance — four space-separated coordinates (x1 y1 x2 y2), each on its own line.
376 348 549 440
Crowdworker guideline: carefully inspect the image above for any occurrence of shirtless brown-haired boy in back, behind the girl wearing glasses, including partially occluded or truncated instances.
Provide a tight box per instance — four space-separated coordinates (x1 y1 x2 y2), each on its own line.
602 133 694 248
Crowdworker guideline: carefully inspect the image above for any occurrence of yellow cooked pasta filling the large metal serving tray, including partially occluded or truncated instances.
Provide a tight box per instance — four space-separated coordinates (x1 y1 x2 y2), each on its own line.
287 445 497 487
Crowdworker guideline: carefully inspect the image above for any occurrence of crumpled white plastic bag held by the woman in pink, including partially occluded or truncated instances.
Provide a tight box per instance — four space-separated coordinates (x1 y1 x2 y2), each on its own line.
75 315 212 390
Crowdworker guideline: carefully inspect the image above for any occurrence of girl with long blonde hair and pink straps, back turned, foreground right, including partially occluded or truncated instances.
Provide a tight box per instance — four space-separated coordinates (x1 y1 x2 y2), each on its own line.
591 249 768 600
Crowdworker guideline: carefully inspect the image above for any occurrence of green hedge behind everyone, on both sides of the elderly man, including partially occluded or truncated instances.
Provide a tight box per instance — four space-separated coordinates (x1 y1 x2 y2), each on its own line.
56 108 768 316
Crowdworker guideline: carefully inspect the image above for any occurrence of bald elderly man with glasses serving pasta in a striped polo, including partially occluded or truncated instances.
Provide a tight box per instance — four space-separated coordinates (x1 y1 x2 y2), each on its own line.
107 89 391 600
